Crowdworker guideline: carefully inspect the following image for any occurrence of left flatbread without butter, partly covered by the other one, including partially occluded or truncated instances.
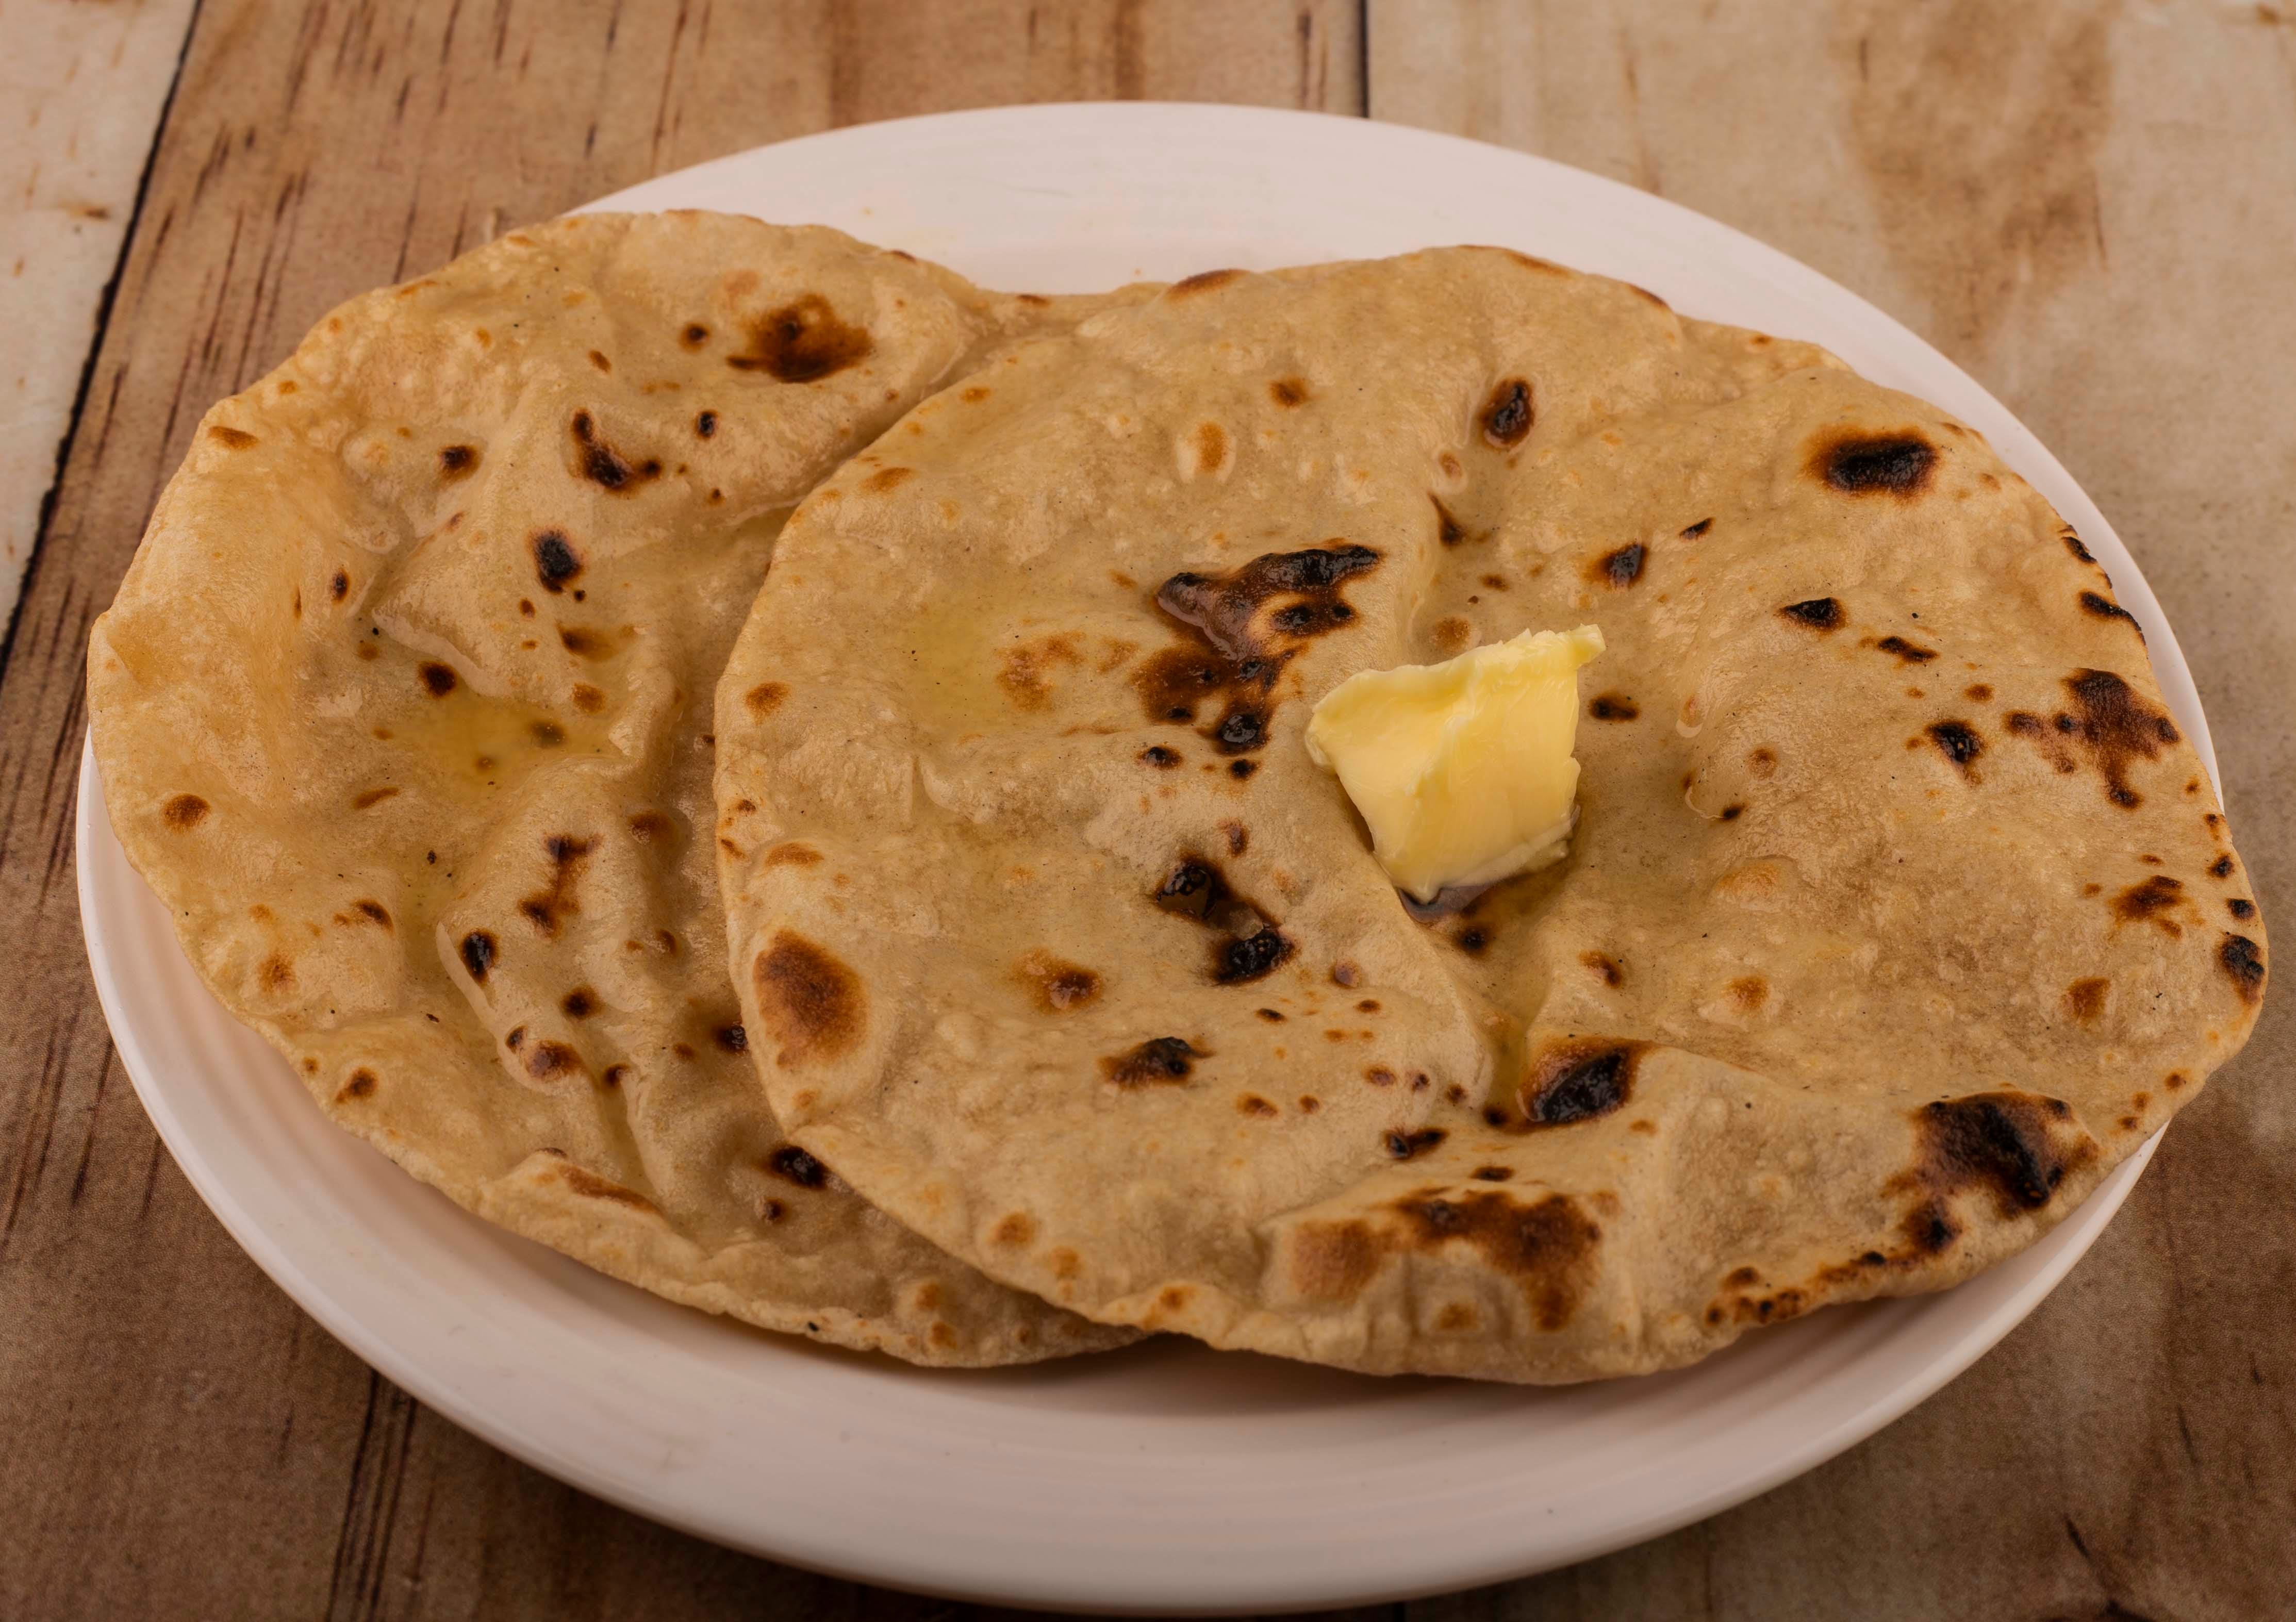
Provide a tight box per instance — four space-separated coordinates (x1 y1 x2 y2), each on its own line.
87 213 1127 1365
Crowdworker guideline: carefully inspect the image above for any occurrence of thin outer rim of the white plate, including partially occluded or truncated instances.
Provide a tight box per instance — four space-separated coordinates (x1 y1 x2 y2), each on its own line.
73 101 2218 1613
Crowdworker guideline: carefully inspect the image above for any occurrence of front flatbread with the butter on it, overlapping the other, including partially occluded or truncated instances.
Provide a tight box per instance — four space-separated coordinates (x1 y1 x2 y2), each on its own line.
716 248 2264 1381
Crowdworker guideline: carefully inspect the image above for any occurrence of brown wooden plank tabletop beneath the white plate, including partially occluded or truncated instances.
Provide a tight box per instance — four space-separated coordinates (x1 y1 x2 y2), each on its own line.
0 0 2296 1622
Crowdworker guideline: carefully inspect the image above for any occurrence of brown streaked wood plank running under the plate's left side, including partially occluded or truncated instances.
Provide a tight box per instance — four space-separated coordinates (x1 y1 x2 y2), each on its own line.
0 0 1362 1617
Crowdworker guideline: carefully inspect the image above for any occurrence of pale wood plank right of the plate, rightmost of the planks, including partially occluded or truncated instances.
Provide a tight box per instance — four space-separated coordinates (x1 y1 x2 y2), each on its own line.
1370 0 2296 1622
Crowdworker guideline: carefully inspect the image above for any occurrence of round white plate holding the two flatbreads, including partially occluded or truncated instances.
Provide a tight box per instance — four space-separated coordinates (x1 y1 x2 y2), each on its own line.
78 104 2216 1613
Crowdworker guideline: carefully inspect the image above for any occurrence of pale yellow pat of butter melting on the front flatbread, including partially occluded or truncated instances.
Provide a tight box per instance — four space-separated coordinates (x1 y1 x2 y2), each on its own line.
1307 625 1603 901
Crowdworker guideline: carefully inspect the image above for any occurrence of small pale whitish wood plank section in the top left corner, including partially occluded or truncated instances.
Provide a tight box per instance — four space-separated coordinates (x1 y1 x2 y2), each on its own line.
0 0 193 643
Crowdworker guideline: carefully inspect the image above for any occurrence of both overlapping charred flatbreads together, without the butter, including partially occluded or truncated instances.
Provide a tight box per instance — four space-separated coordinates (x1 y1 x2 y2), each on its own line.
90 213 2266 1381
